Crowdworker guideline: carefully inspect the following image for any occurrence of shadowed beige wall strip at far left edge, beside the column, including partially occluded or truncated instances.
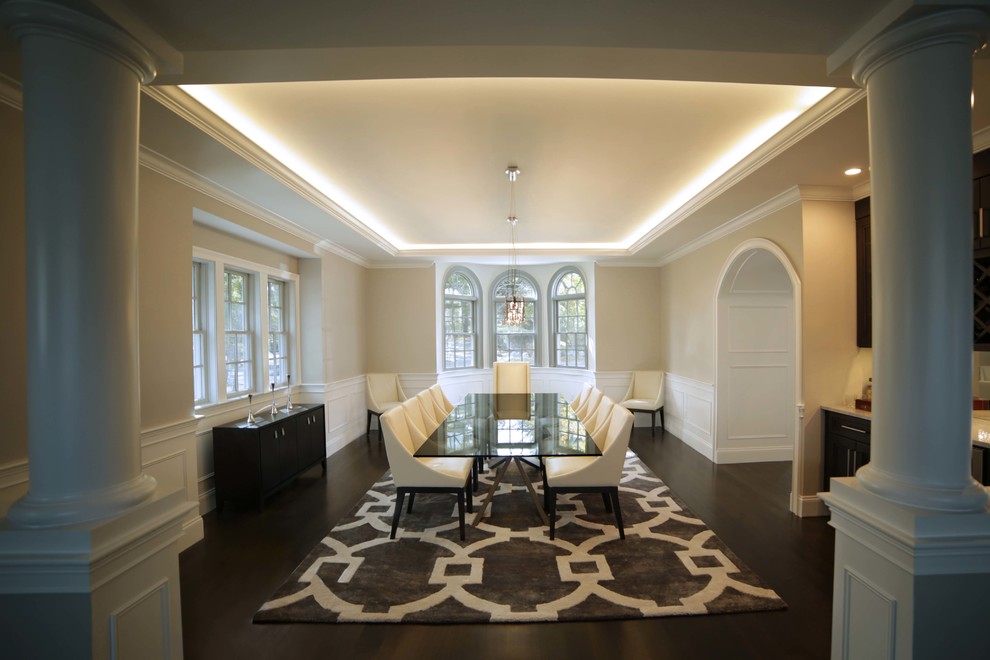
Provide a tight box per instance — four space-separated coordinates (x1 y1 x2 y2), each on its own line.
0 103 28 467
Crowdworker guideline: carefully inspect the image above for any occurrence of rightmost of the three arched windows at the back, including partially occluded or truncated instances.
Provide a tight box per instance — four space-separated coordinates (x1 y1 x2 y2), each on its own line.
550 267 588 369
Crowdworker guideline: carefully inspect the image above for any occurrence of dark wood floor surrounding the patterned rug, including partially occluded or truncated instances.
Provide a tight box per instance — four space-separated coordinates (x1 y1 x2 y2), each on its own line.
179 429 834 660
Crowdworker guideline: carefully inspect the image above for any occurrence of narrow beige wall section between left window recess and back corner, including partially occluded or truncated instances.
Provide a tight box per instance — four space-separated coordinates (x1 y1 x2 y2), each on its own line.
323 254 375 383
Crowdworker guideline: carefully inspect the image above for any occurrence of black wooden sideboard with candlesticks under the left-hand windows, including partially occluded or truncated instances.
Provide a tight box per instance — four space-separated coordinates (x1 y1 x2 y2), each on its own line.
213 403 327 511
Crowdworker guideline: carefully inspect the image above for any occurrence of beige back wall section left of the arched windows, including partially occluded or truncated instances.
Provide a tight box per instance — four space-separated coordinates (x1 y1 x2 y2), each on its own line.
365 266 437 374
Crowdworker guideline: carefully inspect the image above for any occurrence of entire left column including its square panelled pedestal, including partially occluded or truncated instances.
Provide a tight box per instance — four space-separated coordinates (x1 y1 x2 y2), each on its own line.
0 0 196 658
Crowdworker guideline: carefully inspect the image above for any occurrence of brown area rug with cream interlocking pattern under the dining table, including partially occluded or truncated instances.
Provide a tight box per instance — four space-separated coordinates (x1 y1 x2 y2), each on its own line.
254 452 786 623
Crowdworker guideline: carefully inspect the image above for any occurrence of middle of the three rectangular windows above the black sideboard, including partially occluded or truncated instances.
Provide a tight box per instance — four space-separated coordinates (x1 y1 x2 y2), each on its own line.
223 269 255 397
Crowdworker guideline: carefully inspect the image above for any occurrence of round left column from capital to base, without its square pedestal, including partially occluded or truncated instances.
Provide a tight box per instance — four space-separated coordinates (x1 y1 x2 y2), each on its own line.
2 0 155 528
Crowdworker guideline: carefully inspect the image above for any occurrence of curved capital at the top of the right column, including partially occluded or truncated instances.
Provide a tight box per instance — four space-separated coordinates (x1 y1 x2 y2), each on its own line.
852 7 990 87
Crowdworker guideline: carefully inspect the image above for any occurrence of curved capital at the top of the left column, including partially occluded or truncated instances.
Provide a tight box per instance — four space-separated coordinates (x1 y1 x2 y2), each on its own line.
0 0 157 84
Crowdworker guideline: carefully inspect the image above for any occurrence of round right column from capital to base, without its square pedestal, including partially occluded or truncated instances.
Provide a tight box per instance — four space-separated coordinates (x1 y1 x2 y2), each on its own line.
853 5 987 511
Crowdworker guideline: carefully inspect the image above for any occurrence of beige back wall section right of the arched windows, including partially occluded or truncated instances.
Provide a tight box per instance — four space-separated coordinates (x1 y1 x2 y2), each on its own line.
595 265 666 371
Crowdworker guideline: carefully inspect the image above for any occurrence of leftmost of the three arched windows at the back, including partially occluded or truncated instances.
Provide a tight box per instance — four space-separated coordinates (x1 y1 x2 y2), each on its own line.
443 268 481 369
